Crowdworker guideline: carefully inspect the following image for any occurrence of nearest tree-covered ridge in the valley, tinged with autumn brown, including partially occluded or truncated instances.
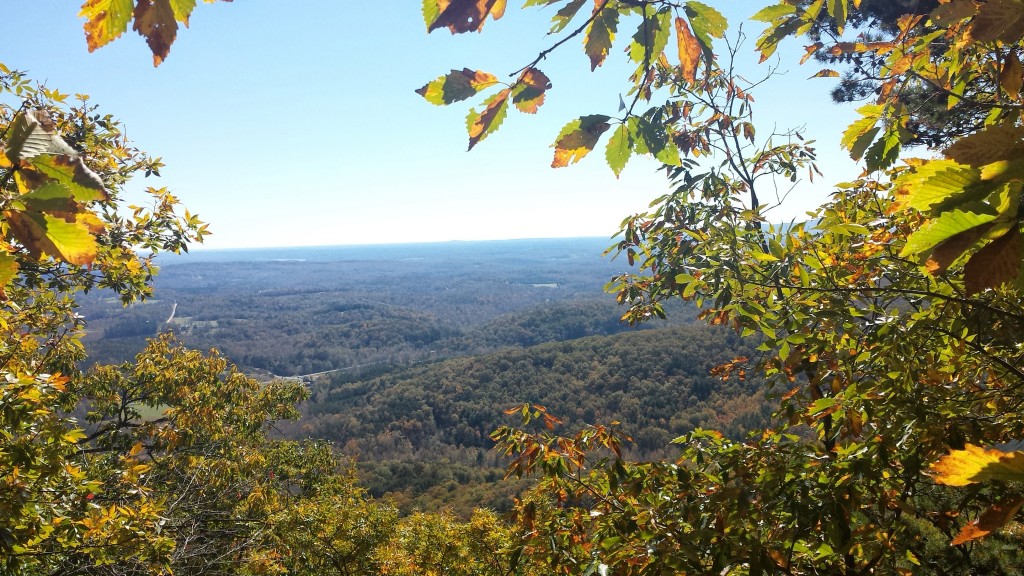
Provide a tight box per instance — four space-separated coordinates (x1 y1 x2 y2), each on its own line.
279 324 771 516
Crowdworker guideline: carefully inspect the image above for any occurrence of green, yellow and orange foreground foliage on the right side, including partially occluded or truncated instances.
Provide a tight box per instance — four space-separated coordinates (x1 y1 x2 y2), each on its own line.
418 0 1024 574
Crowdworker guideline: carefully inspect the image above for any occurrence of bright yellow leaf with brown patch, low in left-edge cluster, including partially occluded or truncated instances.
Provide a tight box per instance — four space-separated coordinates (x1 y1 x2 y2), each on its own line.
4 210 96 265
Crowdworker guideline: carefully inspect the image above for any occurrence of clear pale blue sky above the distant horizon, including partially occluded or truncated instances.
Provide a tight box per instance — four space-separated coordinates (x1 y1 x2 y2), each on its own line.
6 0 856 248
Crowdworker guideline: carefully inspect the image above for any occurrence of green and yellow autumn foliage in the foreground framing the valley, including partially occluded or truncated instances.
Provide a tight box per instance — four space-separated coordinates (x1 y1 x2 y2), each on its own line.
0 0 1024 575
